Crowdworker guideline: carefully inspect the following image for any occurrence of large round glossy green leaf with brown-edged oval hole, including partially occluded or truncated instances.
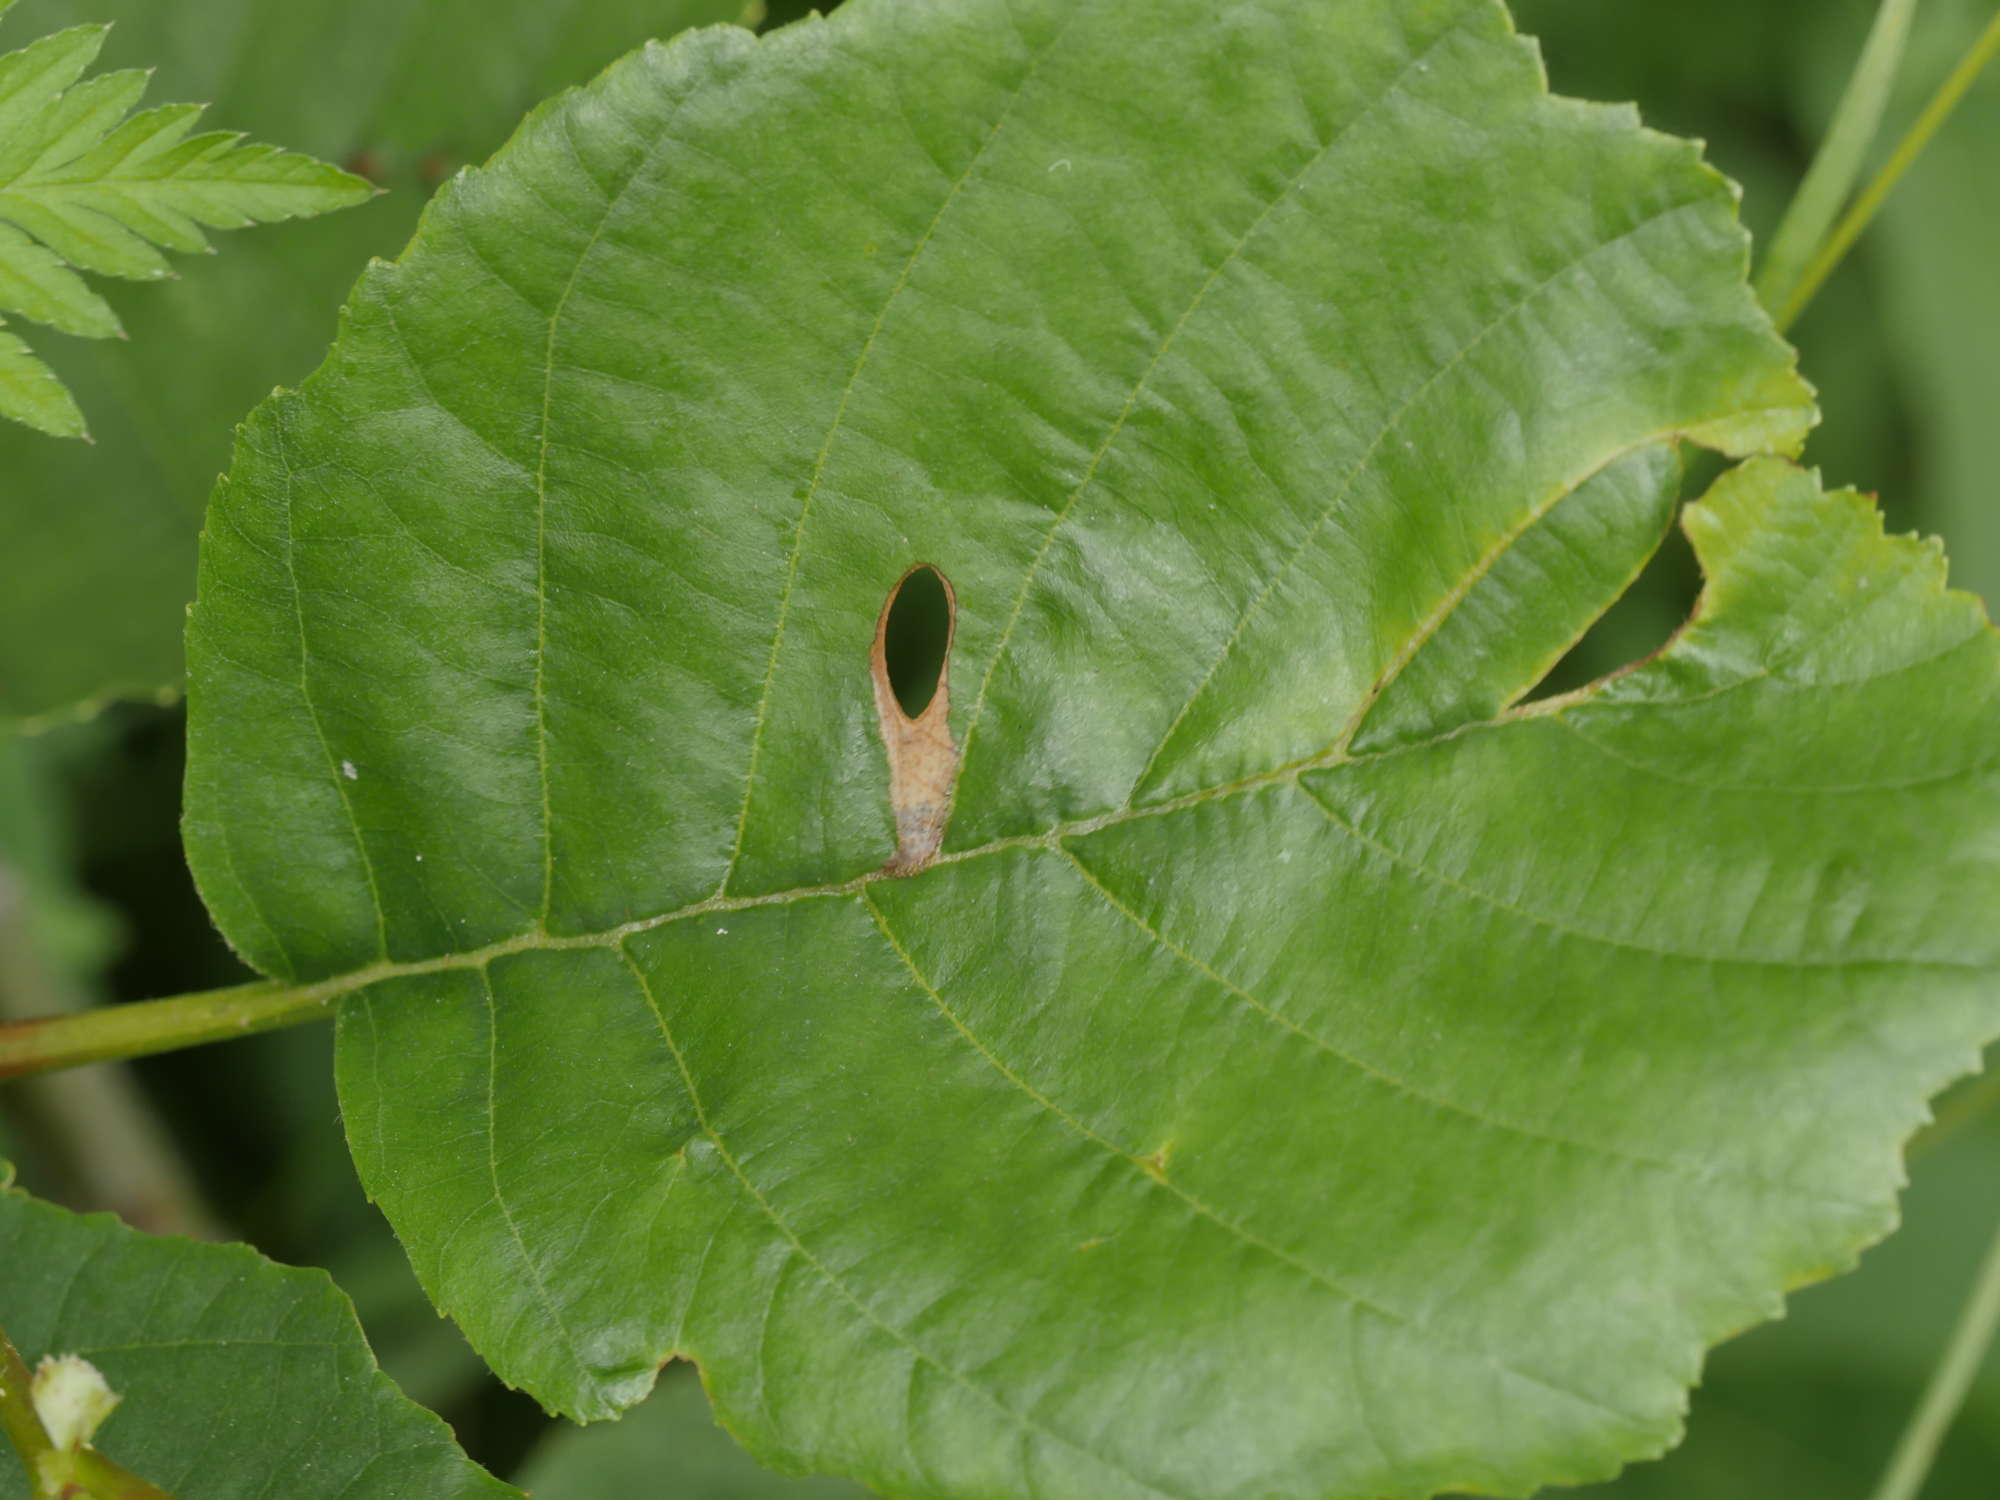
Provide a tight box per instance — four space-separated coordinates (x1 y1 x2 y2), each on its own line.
188 0 2000 1500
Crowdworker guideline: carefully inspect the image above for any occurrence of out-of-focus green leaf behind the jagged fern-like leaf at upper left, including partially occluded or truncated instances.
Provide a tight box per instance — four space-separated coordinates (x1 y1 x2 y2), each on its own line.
0 0 746 728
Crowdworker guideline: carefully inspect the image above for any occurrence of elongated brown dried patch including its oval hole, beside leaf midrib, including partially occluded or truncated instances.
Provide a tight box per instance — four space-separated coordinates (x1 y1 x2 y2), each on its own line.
868 562 958 876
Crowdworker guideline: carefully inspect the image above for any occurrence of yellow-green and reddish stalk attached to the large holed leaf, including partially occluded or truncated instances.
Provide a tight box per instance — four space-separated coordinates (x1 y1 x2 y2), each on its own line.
0 978 340 1082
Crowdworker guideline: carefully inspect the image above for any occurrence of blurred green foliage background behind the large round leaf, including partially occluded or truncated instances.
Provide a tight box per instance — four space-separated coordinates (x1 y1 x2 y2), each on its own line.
0 0 2000 1500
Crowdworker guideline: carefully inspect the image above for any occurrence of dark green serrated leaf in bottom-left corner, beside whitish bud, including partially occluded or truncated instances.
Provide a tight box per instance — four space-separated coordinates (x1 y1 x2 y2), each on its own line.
0 1172 520 1500
